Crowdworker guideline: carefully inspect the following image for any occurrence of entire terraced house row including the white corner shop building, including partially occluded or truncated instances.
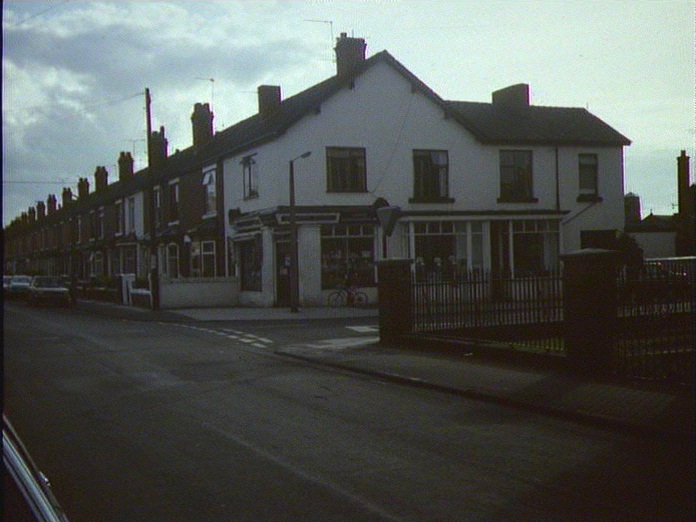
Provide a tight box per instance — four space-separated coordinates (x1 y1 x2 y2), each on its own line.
5 33 630 307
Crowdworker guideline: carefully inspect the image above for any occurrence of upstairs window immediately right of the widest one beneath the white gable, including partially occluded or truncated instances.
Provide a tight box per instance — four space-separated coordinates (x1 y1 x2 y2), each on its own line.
411 150 452 203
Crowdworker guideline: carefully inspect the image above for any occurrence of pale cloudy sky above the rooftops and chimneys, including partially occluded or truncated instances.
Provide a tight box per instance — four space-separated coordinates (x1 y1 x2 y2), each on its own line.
2 0 696 226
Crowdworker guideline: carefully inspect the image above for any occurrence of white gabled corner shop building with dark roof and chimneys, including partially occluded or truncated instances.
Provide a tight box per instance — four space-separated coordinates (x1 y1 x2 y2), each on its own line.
218 33 630 306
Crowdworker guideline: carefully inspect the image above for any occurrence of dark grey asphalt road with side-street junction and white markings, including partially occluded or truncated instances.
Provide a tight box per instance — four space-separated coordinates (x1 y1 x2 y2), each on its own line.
4 303 694 522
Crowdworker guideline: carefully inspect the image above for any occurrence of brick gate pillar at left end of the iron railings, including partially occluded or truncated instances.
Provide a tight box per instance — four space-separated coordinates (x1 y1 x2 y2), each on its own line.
377 259 413 343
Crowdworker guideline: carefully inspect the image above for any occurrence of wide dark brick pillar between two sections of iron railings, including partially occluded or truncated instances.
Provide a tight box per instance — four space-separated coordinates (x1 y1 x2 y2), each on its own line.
561 248 618 375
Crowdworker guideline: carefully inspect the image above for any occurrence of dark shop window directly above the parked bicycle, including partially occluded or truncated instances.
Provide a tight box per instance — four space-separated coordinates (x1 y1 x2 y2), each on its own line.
321 225 375 289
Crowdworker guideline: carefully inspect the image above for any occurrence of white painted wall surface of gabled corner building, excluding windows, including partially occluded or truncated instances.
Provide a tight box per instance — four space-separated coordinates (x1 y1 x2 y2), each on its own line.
223 63 624 305
